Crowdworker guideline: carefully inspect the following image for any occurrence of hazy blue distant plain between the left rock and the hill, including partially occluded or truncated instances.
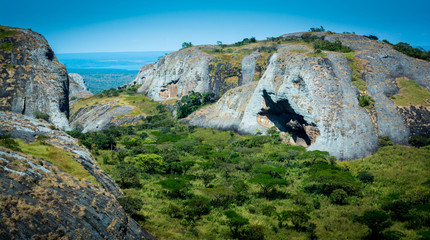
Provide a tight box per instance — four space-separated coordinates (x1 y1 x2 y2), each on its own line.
56 51 170 93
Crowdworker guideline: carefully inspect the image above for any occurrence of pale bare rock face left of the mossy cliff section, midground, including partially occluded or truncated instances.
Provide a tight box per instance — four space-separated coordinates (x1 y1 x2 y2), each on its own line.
129 47 213 101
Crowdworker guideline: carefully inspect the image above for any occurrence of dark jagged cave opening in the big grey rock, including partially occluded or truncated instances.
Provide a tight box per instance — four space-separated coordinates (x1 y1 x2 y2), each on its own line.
259 90 319 146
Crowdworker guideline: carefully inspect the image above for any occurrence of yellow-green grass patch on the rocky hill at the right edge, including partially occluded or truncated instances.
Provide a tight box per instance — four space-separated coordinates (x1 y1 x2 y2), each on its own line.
391 78 430 106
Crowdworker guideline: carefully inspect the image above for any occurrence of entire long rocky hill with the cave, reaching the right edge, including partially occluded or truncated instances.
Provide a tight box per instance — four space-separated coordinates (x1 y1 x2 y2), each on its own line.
135 32 430 159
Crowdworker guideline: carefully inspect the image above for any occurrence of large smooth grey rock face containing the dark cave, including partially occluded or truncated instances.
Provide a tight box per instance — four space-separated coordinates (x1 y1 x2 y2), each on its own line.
186 33 430 159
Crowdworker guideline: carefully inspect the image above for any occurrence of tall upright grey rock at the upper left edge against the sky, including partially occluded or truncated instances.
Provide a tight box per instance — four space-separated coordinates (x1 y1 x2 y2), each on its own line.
0 26 69 129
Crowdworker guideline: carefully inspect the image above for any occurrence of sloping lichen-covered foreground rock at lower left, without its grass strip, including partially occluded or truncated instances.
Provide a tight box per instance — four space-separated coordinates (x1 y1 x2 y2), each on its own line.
0 112 154 239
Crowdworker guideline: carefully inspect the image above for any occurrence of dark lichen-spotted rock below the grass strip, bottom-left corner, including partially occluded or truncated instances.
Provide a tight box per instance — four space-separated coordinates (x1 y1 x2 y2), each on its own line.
0 147 154 240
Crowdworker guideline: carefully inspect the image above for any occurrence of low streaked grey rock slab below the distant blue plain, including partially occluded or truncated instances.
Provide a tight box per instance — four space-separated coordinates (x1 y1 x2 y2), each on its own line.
70 101 145 132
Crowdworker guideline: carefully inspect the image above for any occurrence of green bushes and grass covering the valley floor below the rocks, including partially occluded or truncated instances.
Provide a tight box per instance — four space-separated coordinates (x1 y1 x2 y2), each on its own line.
63 90 430 239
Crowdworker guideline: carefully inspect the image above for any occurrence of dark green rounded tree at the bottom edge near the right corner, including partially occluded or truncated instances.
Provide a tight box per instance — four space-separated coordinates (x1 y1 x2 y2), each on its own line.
357 210 393 239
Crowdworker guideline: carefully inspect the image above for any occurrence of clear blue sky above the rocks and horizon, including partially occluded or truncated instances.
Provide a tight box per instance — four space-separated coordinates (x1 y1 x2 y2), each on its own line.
0 0 430 53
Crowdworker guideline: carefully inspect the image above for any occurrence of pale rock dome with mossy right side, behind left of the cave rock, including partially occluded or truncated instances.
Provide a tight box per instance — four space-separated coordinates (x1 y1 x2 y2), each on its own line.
128 44 269 101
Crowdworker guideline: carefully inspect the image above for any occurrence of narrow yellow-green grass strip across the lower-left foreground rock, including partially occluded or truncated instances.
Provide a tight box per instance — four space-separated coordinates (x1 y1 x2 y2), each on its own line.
16 139 99 184
